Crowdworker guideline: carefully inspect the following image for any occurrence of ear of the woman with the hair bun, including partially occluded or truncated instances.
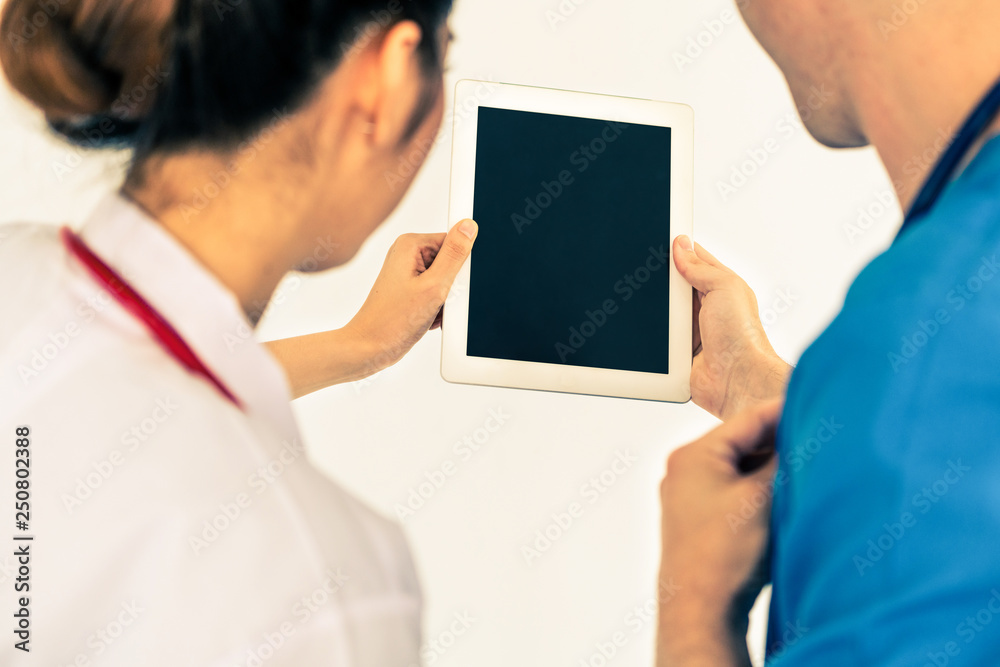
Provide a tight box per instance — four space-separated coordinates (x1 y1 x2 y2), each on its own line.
362 21 425 149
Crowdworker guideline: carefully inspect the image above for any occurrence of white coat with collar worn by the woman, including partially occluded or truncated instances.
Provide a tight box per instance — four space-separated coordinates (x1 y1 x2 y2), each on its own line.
0 196 421 667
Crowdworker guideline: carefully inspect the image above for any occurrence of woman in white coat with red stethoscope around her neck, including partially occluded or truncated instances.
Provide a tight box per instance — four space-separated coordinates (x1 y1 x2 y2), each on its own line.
0 0 477 667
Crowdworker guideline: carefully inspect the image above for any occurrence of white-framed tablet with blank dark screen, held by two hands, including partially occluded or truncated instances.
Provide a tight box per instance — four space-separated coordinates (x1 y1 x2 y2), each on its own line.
441 80 694 402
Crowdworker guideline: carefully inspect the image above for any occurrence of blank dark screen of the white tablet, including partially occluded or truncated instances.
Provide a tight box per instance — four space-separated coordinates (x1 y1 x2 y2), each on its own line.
467 107 671 373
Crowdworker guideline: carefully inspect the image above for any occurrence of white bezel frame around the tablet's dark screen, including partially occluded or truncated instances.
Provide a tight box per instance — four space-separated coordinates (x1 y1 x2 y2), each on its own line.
441 80 694 403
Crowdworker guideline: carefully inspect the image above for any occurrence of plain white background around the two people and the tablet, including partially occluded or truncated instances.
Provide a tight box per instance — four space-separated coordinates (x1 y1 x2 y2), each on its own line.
0 0 901 667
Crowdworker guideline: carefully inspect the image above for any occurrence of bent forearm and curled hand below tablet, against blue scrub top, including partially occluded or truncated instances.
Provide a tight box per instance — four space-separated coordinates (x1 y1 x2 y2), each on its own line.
657 400 781 667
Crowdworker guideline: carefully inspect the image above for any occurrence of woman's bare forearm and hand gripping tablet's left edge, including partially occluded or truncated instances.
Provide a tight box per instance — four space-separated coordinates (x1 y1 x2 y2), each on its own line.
267 220 479 398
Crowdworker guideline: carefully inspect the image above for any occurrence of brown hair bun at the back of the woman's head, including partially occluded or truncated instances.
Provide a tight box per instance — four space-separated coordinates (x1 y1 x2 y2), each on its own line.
0 0 174 134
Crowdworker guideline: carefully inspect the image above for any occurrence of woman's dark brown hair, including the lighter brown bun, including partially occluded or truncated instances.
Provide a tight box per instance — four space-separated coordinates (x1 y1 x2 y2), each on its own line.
0 0 451 155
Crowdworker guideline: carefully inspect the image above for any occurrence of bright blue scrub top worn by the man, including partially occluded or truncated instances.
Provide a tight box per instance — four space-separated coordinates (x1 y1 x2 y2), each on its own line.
768 137 1000 667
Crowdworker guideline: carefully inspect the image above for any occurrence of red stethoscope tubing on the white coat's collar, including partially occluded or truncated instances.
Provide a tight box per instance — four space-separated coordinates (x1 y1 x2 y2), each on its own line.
60 227 243 410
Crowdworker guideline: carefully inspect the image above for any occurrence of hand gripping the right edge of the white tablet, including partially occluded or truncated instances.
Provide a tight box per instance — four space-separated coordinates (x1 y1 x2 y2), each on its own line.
674 236 791 420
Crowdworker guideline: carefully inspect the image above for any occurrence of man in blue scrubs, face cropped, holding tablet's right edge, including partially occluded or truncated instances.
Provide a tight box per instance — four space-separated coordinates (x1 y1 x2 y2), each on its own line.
658 0 1000 667
